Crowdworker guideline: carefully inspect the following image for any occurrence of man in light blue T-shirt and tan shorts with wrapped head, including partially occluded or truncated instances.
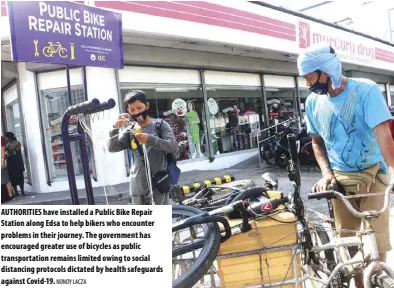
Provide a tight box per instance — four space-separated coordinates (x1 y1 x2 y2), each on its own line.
297 45 394 287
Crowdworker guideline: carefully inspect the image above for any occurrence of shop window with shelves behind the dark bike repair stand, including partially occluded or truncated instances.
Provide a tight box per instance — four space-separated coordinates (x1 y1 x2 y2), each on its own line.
41 87 92 178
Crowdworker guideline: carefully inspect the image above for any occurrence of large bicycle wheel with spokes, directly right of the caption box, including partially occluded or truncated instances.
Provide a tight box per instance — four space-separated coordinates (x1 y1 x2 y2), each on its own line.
172 205 221 288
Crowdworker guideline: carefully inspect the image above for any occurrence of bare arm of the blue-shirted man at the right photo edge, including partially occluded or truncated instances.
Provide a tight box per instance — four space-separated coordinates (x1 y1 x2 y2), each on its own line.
374 122 394 180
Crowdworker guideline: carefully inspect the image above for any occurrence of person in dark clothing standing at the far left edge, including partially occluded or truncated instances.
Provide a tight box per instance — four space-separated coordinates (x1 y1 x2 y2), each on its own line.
5 132 25 196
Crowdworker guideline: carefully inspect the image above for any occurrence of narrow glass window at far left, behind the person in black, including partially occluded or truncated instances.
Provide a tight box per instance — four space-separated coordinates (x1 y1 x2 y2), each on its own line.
6 101 28 180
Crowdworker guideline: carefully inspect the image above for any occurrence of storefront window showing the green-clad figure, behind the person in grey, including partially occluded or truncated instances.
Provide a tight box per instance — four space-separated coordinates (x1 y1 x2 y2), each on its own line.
121 85 209 161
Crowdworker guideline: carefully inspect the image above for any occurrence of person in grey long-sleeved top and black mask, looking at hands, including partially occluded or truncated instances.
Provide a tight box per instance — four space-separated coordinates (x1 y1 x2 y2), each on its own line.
108 90 178 205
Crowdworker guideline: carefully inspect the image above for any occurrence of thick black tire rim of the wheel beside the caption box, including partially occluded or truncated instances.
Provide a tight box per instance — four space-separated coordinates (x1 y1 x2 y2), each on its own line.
172 205 221 288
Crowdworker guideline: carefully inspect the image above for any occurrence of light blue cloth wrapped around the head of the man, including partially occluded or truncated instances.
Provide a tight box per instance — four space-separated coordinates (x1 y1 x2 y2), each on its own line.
297 44 342 89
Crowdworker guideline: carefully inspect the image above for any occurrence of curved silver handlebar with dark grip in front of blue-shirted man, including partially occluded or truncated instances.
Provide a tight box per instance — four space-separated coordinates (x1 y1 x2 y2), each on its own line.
308 184 394 218
